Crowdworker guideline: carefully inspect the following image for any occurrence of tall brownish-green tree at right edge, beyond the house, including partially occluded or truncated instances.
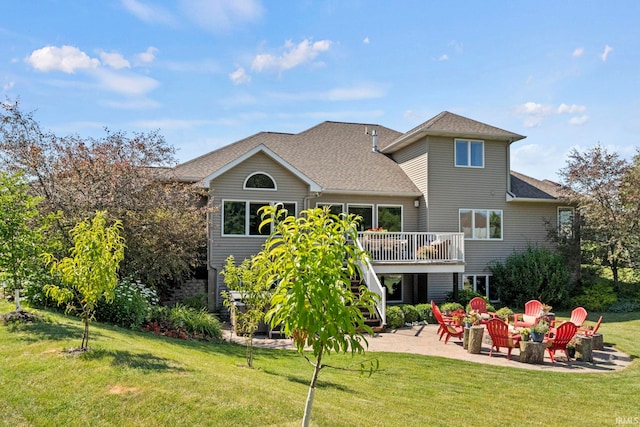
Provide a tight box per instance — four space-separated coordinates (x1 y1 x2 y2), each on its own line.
560 145 640 288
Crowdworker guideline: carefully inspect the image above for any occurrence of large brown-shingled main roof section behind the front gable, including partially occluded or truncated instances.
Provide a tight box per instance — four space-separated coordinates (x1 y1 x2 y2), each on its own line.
175 122 420 195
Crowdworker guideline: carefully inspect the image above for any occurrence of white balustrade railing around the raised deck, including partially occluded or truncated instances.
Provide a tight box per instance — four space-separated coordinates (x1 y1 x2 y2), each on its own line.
358 231 464 263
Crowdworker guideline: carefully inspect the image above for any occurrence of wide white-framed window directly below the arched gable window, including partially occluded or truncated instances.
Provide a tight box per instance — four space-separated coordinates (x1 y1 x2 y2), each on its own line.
222 200 296 236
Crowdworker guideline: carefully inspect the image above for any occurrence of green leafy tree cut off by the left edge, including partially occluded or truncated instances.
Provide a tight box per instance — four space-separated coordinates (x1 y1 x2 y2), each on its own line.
0 171 54 311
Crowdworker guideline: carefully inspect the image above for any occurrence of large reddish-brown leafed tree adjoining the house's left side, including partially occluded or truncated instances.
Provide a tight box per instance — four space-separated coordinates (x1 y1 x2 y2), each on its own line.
0 101 207 291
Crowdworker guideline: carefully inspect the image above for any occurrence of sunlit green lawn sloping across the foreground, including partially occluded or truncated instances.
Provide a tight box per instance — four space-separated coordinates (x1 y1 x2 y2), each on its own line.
0 301 640 426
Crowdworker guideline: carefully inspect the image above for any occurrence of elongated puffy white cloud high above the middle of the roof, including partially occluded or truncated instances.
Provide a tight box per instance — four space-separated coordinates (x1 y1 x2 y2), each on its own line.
251 39 331 72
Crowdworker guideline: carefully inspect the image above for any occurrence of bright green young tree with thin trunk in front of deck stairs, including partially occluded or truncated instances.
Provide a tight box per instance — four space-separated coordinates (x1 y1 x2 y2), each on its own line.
254 206 375 426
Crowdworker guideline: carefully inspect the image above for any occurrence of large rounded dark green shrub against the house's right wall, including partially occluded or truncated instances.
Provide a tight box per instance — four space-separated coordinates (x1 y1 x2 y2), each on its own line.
489 245 570 307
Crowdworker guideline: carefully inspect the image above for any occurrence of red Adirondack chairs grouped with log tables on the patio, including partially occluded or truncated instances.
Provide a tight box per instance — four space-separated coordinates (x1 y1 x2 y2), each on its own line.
431 297 603 364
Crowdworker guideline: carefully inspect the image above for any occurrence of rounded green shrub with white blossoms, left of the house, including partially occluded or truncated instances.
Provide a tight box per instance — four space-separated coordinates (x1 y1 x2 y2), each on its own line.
95 278 158 329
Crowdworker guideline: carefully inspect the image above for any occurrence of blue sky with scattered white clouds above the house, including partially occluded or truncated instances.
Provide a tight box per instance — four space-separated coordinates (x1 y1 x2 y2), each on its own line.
0 0 640 180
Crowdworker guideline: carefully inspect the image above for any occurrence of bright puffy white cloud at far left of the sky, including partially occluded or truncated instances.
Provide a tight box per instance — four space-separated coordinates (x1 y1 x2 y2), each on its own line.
25 46 100 74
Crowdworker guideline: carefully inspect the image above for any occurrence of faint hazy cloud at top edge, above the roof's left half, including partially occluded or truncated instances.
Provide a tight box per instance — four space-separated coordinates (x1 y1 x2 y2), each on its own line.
180 0 263 32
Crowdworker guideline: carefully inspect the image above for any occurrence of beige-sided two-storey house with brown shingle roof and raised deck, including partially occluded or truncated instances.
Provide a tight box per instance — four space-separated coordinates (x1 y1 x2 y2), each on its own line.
175 112 573 318
